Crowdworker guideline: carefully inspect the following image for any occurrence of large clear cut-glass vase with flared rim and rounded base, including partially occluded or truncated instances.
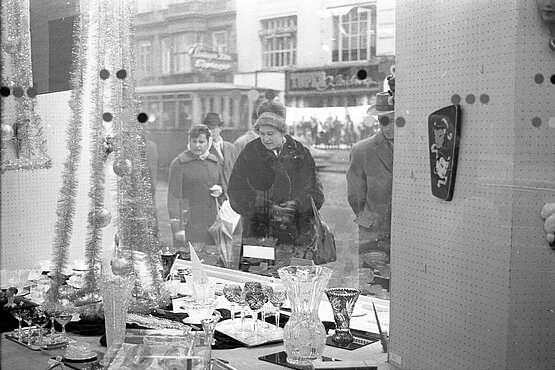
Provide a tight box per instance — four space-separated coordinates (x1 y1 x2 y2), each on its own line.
278 266 332 366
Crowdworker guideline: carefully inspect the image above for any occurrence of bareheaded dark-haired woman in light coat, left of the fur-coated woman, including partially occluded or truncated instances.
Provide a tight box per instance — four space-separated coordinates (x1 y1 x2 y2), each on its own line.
168 124 223 251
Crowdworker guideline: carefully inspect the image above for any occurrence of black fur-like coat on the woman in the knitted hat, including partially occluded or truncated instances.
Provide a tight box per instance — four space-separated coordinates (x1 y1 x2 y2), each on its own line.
228 135 324 244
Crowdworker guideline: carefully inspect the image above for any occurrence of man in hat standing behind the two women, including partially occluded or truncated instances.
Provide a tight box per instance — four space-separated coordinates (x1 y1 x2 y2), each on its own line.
202 113 237 189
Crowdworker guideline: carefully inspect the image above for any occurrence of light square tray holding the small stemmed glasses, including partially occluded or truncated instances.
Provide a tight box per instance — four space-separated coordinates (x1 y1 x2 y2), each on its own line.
216 319 283 347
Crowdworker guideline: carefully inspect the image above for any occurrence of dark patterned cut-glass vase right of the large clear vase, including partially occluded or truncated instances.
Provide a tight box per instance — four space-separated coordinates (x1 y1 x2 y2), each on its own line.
326 288 360 345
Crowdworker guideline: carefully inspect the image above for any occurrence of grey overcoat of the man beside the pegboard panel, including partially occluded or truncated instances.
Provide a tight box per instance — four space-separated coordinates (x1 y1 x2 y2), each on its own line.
347 131 393 246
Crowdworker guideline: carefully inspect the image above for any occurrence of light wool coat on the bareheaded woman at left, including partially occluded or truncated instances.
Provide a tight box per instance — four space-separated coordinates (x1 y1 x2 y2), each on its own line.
168 150 223 244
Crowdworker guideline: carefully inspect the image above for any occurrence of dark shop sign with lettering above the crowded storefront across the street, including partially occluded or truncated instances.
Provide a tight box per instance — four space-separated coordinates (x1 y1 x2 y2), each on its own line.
286 66 385 91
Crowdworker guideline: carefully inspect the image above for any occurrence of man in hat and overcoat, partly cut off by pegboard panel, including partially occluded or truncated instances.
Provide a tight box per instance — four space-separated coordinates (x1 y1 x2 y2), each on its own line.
347 92 395 262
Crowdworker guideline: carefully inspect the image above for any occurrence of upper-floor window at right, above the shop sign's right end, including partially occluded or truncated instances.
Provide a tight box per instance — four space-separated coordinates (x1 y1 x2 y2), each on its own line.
331 5 376 62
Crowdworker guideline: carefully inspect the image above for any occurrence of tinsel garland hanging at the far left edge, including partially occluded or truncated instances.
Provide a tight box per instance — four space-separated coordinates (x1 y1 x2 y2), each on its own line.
0 0 52 172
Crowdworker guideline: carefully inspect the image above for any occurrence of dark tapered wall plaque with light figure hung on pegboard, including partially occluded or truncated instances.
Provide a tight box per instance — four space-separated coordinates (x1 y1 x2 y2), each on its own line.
428 104 461 200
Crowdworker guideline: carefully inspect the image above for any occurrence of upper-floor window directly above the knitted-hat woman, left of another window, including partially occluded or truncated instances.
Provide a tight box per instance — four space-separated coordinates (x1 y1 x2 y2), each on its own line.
259 16 297 67
